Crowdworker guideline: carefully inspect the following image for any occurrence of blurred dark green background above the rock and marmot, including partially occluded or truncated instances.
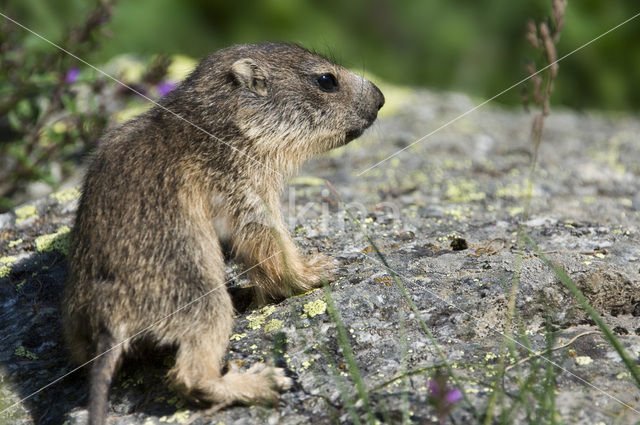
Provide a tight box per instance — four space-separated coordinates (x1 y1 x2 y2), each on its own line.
2 0 640 110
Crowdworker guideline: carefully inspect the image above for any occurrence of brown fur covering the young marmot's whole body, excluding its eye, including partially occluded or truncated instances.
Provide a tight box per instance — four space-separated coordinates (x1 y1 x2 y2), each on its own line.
63 43 384 423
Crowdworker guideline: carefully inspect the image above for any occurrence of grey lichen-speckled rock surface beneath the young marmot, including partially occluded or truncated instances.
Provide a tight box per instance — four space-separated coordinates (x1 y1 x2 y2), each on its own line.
0 89 640 425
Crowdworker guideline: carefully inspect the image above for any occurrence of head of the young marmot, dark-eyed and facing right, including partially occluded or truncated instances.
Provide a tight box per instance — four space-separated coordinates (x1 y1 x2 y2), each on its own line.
172 43 384 160
